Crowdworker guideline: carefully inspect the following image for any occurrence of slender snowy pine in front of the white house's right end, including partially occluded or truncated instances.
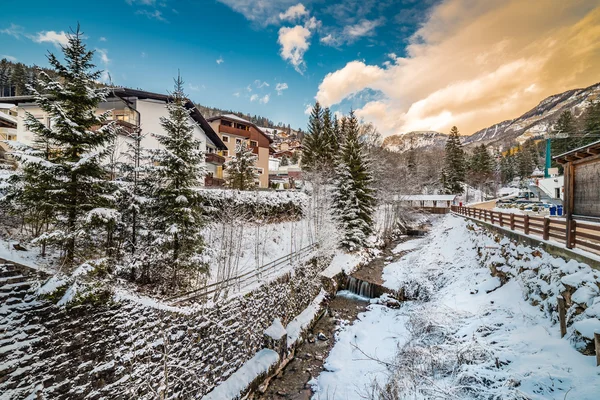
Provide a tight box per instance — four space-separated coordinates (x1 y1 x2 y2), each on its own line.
146 76 206 287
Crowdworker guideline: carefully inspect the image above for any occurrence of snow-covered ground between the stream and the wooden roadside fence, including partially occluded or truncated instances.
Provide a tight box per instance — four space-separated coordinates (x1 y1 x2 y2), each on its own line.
311 215 600 400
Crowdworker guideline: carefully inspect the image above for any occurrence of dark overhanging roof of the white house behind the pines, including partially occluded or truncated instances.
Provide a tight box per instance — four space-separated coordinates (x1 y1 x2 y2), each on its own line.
0 87 227 150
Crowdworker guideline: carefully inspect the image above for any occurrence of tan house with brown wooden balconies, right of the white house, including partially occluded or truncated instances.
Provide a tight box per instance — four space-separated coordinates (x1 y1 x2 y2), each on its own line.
208 114 273 188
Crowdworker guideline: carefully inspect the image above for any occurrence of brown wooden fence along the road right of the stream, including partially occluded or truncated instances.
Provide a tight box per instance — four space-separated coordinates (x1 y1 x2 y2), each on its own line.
452 206 600 254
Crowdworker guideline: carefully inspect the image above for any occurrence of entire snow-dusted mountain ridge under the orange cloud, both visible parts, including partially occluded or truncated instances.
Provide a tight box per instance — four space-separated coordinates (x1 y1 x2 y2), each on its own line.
383 83 600 153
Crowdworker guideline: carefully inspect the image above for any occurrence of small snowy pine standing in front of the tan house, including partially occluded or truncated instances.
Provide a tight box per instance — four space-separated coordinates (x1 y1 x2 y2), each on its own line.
224 141 258 190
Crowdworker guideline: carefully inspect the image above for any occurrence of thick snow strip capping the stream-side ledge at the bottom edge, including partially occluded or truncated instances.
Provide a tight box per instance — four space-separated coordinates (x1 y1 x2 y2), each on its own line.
203 349 279 400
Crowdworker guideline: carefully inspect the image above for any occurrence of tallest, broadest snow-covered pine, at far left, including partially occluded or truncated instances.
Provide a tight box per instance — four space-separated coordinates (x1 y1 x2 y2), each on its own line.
7 26 115 265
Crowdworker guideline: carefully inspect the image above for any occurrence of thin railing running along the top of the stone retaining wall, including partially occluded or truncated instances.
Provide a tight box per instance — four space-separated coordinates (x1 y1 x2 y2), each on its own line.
167 243 317 304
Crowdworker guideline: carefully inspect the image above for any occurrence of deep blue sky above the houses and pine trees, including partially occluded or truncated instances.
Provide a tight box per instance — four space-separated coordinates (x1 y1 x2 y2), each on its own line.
0 0 433 129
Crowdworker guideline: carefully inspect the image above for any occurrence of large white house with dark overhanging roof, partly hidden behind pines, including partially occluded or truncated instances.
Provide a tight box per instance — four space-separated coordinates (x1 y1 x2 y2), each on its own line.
0 87 228 186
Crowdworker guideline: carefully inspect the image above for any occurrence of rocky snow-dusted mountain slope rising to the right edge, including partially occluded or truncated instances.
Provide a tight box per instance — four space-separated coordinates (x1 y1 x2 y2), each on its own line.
463 83 600 146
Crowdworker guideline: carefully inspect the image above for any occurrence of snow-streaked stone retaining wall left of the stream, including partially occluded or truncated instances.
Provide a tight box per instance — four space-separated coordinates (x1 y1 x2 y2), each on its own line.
0 260 324 399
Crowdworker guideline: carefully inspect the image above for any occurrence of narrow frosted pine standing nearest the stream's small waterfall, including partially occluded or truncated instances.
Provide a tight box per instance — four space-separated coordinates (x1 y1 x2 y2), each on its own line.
333 111 375 251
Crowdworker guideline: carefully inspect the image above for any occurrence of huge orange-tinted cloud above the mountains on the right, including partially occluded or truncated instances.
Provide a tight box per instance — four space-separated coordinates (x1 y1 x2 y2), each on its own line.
316 0 600 135
